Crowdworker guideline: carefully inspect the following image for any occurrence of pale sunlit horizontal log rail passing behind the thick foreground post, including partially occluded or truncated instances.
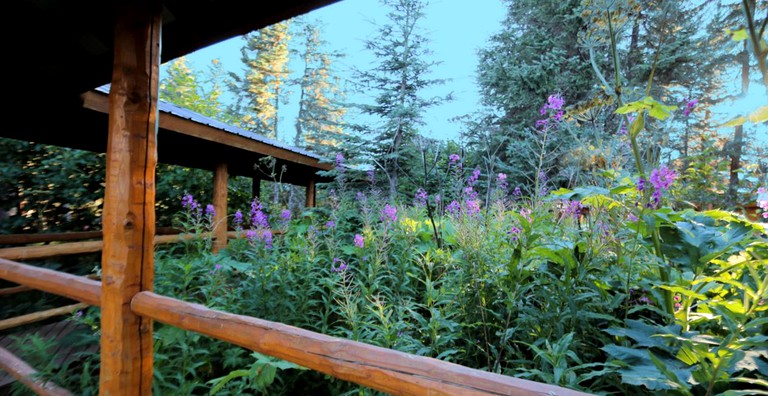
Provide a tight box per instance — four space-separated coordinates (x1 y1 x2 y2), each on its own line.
0 231 245 261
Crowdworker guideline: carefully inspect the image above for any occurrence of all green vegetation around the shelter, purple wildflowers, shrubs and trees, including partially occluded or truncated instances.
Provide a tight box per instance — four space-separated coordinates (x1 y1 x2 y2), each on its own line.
0 0 768 395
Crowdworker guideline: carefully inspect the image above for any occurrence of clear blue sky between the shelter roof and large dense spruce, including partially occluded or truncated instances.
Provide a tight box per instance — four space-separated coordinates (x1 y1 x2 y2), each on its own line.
166 0 505 141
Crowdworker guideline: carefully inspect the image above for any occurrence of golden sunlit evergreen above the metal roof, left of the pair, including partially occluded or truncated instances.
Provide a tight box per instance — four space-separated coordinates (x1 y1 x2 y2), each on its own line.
230 21 291 139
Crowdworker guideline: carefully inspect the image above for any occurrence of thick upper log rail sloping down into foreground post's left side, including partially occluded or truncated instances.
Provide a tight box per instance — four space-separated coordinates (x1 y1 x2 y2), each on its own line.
0 258 101 306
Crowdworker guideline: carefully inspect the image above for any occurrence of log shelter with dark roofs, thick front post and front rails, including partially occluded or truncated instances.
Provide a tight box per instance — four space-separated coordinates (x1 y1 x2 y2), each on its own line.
0 0 578 395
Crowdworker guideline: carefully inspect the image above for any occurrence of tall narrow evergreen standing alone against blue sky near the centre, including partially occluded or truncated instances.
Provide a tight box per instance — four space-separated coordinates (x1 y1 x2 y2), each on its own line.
358 0 448 199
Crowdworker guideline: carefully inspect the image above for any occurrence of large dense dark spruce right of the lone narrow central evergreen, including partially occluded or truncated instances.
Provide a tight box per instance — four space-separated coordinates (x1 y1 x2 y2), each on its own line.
474 0 595 190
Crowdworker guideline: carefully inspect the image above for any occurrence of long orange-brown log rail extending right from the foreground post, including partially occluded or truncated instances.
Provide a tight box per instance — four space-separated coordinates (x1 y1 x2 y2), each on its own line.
131 292 585 395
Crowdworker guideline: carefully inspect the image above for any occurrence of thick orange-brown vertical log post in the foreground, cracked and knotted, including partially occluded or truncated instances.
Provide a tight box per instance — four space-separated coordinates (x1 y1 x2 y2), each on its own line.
99 0 161 395
